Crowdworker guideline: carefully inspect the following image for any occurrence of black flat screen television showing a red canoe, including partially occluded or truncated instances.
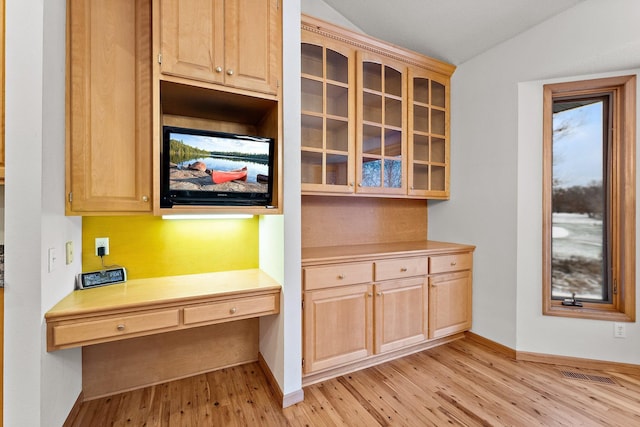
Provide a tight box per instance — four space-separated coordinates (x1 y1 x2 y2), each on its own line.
160 126 275 208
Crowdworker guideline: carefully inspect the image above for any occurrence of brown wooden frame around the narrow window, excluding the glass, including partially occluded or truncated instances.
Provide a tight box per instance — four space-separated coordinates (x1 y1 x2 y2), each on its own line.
542 75 636 322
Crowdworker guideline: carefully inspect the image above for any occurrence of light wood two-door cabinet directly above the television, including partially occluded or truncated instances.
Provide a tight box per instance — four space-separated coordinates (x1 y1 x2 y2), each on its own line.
158 0 282 94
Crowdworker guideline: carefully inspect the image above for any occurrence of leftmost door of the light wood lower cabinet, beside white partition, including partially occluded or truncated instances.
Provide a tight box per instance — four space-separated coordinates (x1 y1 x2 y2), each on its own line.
303 284 373 374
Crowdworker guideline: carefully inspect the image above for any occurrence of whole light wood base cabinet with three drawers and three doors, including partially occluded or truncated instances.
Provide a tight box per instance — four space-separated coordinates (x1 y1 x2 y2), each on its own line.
302 241 474 385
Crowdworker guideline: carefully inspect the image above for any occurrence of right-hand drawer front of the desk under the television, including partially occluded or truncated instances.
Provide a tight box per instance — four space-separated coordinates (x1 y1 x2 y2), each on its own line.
184 294 280 325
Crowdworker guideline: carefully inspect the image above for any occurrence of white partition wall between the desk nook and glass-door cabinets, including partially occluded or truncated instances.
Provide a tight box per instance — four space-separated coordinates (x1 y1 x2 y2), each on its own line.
260 1 302 400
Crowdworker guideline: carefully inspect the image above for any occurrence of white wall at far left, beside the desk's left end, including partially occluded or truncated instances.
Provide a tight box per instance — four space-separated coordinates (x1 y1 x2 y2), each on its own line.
4 0 82 426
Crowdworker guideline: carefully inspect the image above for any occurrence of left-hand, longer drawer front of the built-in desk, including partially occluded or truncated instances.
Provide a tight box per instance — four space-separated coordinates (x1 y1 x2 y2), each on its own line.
53 309 180 346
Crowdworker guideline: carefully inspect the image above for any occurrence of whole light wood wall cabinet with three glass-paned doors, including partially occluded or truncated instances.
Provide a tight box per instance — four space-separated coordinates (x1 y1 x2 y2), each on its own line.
301 16 455 199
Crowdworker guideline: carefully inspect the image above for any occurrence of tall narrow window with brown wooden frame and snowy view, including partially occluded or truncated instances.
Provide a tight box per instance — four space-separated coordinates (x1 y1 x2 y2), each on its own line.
542 76 636 321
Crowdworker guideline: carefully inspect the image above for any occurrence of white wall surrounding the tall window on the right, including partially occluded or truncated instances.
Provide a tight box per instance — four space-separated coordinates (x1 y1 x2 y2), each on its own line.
429 0 640 364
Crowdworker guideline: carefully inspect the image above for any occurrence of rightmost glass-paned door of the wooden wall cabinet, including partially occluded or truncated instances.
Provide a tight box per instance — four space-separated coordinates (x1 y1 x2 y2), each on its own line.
407 69 449 198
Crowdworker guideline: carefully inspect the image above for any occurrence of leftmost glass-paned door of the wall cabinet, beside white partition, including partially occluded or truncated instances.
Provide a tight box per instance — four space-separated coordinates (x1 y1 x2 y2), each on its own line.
300 38 355 193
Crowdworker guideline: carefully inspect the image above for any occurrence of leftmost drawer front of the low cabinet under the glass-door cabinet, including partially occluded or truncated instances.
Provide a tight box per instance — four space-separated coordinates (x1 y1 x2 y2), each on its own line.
303 262 373 291
